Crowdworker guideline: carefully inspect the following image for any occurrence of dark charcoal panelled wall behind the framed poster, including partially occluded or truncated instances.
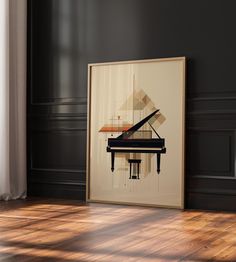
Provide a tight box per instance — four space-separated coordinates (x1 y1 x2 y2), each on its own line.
28 0 236 210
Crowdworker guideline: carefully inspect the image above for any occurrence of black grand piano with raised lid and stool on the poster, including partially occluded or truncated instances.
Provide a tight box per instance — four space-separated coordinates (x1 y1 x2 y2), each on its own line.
107 109 166 179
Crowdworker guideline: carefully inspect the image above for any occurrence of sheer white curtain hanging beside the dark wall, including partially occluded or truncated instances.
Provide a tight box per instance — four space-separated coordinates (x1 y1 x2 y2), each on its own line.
0 0 27 200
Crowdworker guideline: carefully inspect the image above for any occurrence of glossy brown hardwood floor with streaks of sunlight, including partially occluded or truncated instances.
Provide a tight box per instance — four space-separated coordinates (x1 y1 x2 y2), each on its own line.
0 199 236 262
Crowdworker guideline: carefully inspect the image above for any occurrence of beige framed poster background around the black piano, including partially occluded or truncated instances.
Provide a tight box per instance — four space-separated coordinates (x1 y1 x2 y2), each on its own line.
87 57 185 208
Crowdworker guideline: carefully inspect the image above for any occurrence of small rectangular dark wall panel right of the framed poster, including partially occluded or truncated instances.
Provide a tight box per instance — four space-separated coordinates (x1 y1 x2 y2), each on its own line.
187 130 235 178
